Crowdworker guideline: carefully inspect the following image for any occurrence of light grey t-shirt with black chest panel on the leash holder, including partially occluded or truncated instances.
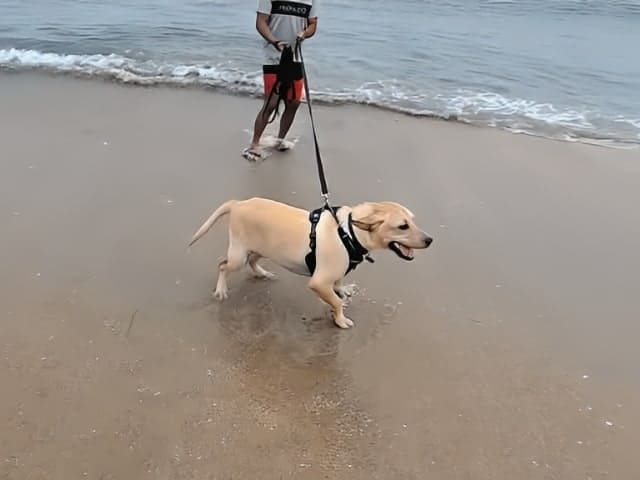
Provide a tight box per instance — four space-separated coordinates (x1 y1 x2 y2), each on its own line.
258 0 318 65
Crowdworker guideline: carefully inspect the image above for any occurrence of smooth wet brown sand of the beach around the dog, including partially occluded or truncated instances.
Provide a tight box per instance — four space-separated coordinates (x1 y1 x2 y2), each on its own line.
0 73 640 480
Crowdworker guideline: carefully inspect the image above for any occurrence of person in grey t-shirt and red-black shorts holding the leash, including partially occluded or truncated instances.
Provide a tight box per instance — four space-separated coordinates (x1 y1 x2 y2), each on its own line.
243 0 318 160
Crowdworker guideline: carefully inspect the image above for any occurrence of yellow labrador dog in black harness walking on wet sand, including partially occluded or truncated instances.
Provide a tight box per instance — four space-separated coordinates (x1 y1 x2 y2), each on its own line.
189 198 433 328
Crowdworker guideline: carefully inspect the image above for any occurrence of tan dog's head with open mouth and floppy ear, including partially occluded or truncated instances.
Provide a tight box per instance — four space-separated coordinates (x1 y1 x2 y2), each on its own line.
352 202 433 260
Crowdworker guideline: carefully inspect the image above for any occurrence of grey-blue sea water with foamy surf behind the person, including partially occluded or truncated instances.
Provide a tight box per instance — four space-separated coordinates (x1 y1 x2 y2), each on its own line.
0 0 640 147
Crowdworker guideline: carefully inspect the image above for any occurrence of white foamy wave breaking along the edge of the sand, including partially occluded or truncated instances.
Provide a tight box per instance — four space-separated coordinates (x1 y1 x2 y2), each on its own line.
0 48 640 148
